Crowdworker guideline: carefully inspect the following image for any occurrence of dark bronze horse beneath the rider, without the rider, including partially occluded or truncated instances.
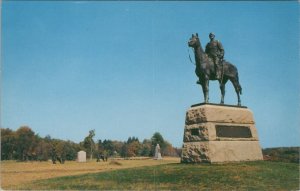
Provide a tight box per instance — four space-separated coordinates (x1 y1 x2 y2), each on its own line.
188 33 242 106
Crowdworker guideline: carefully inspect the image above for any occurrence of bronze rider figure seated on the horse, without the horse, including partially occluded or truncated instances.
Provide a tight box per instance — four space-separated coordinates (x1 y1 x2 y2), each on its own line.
205 33 224 79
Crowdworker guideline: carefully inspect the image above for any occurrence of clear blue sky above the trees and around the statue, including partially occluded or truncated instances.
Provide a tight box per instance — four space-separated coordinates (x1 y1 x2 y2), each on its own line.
1 1 300 148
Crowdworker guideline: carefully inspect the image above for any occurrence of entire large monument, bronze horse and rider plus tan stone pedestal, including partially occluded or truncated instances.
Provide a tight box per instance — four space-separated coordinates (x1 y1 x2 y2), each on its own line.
181 33 263 163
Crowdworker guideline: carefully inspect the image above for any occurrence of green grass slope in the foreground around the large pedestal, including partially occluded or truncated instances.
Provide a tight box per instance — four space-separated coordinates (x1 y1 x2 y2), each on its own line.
20 161 299 190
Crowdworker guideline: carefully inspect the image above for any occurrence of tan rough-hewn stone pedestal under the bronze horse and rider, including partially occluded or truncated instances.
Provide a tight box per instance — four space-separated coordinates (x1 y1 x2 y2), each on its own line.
181 104 263 163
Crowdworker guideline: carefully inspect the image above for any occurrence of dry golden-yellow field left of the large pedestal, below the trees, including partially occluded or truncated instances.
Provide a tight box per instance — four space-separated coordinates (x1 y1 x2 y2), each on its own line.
1 157 180 190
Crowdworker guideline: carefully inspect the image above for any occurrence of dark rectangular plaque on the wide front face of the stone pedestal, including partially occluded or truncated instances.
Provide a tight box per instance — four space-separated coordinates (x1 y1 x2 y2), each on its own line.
216 125 252 138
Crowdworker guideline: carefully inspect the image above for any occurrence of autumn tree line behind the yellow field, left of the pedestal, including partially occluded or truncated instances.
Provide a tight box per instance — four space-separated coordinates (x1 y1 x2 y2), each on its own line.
1 126 181 163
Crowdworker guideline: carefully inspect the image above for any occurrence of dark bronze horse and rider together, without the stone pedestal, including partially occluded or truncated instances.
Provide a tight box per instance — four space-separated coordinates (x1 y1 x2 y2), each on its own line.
188 33 242 106
